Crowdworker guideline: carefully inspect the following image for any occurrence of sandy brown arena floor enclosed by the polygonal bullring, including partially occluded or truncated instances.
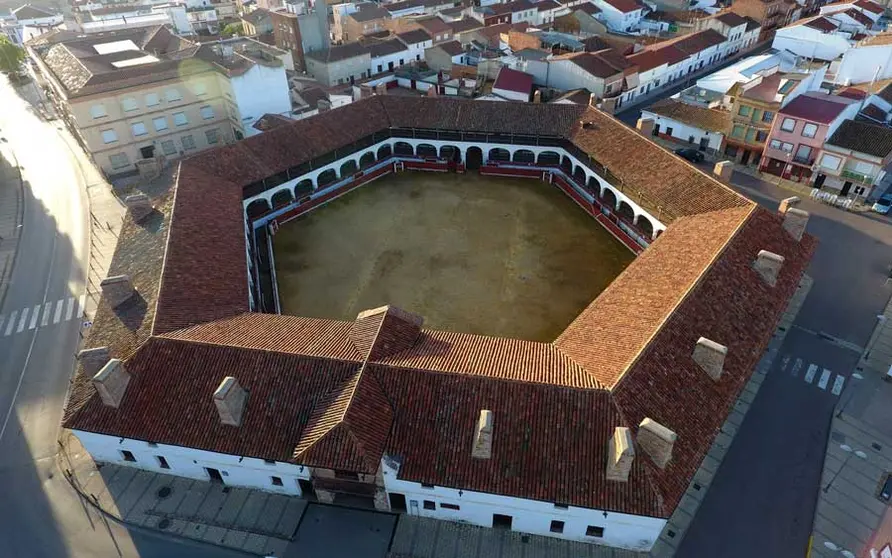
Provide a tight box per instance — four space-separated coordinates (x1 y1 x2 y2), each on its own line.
274 172 633 341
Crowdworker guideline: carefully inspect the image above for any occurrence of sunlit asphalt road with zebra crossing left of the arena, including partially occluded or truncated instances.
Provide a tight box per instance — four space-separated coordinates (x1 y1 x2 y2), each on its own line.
0 76 251 558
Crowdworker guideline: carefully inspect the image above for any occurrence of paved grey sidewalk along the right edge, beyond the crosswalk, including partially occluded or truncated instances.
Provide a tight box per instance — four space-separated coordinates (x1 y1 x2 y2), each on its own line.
809 300 892 558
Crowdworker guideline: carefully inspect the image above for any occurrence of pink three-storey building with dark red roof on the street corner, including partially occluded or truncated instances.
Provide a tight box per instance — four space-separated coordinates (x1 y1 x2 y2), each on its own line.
759 92 861 182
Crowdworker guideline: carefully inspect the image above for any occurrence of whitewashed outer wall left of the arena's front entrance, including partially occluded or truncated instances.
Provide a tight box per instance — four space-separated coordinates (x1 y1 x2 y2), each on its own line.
73 430 310 496
